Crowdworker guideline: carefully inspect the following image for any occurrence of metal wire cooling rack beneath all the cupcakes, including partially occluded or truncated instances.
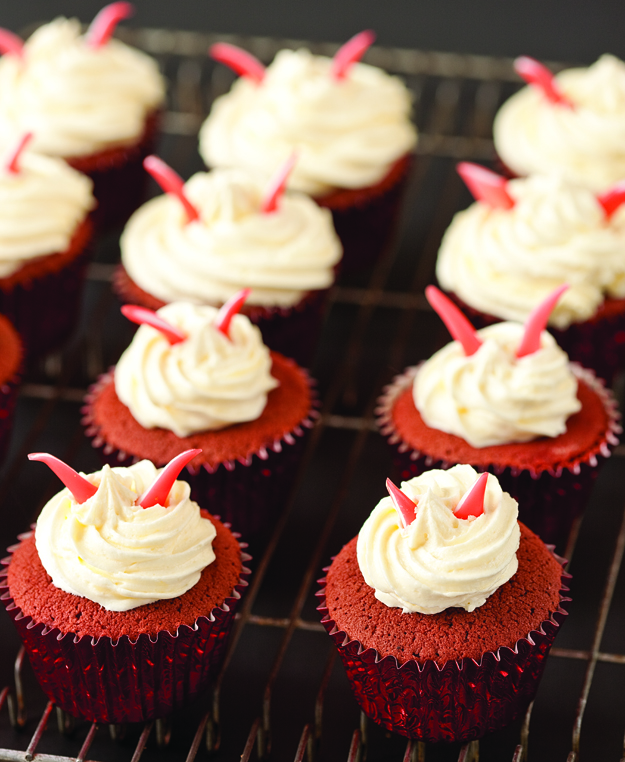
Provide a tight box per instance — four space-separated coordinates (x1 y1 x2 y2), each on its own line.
0 29 625 762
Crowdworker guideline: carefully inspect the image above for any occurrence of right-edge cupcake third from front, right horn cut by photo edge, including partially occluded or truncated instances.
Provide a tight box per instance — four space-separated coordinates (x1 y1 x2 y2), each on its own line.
436 164 625 383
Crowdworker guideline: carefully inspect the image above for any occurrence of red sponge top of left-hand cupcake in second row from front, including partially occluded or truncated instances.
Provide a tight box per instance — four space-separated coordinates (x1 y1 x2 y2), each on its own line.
90 352 312 466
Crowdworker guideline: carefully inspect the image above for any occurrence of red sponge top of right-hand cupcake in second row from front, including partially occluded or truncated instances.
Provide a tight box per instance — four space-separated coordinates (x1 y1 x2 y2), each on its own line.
392 380 609 471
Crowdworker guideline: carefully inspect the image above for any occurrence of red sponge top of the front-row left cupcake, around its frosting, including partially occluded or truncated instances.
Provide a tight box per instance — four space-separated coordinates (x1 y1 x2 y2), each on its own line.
7 511 242 640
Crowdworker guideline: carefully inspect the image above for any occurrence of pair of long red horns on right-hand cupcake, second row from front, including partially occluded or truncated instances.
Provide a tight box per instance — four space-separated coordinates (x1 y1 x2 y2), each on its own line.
425 283 569 358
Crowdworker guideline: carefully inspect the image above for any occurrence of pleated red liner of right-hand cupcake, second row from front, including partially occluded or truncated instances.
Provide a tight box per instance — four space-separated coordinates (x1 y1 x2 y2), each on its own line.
376 363 621 547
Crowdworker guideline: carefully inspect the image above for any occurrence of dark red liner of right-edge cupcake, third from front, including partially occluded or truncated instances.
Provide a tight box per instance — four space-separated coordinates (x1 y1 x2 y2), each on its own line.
447 293 625 386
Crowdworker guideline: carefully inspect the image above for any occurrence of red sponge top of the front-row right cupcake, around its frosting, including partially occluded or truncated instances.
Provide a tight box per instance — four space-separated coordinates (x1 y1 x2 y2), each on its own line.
325 524 562 666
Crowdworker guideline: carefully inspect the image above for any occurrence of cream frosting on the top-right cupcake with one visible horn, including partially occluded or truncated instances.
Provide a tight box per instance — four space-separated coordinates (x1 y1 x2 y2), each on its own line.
493 55 625 191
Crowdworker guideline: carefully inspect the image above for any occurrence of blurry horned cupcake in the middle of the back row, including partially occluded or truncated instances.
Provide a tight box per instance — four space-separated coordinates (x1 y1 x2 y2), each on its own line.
200 32 417 270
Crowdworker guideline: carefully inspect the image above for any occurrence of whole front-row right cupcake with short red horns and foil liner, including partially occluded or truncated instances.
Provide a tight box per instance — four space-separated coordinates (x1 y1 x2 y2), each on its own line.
318 465 569 742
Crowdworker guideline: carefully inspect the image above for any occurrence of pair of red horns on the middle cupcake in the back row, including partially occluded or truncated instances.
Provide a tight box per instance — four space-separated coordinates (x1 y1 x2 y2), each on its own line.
208 29 375 85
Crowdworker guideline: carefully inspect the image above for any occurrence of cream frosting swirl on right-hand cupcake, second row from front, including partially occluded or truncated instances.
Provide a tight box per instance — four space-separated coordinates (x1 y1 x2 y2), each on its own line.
413 323 581 447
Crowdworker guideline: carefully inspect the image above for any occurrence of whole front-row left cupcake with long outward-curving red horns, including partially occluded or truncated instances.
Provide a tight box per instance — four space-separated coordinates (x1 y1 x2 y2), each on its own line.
1 453 249 723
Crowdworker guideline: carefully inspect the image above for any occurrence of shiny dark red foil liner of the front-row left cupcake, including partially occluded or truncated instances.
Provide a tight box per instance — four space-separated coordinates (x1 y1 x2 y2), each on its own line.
0 533 251 723
